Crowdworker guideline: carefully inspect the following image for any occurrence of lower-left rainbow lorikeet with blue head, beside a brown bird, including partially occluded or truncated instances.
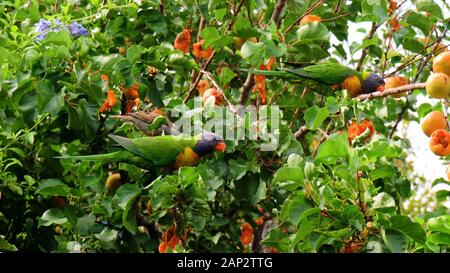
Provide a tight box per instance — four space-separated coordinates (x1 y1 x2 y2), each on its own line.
59 132 226 169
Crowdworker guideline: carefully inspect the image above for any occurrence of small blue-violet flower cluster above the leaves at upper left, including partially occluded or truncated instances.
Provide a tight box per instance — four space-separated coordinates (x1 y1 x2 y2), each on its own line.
35 18 89 42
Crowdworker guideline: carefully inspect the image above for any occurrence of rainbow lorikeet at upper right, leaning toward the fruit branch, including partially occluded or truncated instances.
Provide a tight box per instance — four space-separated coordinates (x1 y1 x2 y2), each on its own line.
241 63 385 97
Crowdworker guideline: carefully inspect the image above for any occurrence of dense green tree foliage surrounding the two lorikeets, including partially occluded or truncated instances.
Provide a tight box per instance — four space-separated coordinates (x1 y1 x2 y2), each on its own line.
0 0 450 252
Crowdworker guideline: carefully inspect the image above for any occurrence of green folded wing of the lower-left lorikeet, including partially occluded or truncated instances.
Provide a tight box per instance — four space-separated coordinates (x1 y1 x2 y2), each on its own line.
109 135 198 166
